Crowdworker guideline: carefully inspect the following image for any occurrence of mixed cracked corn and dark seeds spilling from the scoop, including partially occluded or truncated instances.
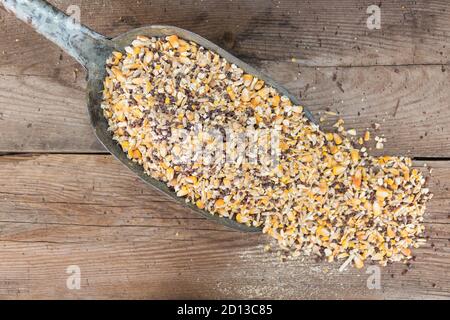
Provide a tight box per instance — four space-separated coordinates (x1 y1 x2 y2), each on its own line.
102 35 431 268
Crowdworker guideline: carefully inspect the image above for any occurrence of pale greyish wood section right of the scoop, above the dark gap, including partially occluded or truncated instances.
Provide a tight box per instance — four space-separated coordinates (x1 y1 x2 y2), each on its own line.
268 63 450 157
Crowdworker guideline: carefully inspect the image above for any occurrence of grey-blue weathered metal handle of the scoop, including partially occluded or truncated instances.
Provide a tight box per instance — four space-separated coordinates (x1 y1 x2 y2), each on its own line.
0 0 111 70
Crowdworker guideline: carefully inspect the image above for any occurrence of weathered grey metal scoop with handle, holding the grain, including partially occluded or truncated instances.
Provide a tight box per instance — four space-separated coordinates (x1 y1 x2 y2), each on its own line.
0 0 314 232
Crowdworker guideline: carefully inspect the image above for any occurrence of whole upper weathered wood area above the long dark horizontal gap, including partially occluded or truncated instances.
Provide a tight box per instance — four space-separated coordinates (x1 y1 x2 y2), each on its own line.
0 0 450 157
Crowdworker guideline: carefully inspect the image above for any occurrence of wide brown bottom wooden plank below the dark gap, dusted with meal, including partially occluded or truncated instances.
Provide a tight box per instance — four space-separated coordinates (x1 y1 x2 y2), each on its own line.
0 155 450 299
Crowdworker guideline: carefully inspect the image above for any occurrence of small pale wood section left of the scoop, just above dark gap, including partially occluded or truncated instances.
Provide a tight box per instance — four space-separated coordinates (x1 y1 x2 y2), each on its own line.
0 76 103 152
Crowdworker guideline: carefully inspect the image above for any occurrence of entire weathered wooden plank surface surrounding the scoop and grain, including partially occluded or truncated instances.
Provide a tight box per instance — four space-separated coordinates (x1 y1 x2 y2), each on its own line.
0 0 450 299
